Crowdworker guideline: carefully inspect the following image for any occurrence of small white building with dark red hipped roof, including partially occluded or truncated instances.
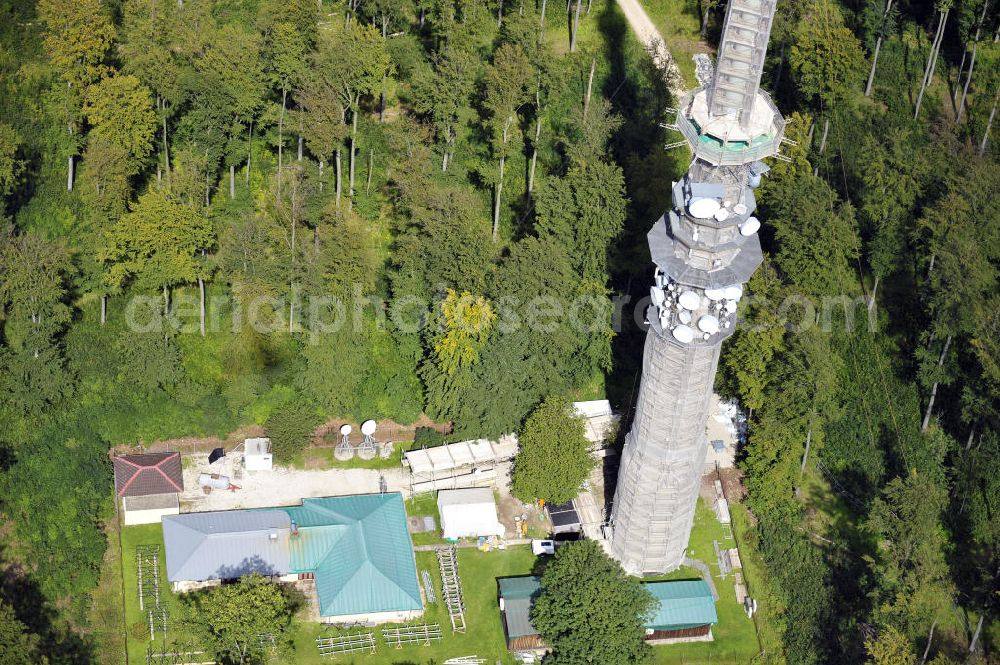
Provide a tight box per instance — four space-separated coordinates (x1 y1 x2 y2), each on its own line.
113 451 184 525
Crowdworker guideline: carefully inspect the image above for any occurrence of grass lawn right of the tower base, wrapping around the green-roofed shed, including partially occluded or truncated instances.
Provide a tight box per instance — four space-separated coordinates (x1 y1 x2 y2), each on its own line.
653 499 760 665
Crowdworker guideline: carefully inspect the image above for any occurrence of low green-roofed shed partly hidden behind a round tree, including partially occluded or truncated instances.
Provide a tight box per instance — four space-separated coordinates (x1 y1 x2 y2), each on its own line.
497 577 719 652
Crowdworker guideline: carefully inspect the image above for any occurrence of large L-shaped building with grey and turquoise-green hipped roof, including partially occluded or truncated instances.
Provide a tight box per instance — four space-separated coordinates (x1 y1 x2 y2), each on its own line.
163 492 423 623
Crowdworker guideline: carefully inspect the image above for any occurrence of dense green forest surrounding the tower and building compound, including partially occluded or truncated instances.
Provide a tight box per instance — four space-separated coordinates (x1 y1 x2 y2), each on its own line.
0 0 1000 665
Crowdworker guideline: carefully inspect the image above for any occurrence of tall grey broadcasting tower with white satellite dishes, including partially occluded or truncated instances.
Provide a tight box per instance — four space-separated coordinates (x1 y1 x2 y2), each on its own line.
609 0 785 575
